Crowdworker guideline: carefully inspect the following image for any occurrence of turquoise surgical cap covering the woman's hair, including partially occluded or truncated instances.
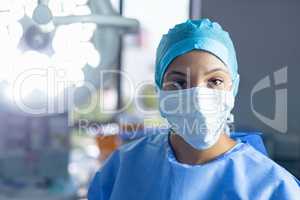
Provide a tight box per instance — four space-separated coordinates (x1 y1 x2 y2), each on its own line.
155 19 239 95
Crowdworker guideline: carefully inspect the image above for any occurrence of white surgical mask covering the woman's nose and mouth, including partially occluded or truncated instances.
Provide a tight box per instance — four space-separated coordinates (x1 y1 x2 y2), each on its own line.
159 87 234 150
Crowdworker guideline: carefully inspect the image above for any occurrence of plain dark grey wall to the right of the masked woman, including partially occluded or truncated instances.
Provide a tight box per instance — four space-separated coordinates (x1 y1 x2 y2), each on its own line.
200 0 300 177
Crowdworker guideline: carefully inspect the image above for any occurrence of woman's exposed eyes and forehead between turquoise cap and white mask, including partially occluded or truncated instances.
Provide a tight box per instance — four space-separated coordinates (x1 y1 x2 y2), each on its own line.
163 50 232 90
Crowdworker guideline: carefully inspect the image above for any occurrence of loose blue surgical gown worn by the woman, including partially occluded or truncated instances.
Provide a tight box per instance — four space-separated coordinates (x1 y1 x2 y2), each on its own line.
88 130 300 200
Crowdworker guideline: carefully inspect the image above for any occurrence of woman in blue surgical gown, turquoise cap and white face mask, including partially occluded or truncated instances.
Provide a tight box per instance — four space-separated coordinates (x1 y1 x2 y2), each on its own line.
88 19 300 200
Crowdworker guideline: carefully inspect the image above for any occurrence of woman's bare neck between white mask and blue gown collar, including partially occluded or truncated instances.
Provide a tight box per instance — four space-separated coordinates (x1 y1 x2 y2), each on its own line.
169 134 236 165
